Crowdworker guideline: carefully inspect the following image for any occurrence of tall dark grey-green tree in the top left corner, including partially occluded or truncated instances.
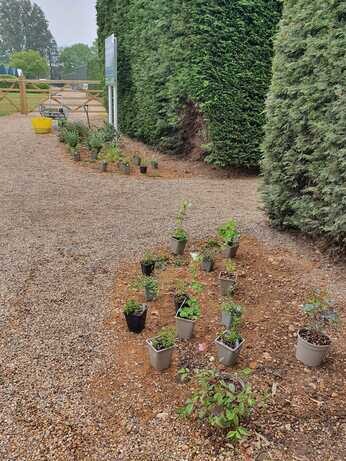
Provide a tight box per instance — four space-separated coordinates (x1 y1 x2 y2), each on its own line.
0 0 56 71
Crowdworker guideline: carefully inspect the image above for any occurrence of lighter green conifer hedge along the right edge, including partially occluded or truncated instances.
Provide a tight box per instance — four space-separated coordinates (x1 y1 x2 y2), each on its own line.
264 0 346 247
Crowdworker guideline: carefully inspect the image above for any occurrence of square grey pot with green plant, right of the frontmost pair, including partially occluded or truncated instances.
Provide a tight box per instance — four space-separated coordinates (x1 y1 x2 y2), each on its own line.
215 319 245 367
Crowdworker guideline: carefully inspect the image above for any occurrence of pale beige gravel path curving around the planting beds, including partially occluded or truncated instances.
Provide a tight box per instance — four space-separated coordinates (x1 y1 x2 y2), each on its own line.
0 115 344 461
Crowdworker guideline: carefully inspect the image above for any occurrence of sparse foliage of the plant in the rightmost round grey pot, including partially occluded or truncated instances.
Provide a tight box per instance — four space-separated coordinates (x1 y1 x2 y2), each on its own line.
302 290 338 334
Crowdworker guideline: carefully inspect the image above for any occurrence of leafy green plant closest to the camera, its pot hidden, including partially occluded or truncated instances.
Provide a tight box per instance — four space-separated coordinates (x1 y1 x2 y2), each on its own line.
178 370 264 443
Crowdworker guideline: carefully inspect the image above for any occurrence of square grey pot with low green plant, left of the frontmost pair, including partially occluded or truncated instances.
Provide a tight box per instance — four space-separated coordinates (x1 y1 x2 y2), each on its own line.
147 328 175 371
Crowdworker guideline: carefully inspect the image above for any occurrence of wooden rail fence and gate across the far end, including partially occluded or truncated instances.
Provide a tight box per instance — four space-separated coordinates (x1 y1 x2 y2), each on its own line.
0 78 106 115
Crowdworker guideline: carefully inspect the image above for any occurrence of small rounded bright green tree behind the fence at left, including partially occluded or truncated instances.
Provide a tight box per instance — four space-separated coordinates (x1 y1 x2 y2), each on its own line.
10 50 49 78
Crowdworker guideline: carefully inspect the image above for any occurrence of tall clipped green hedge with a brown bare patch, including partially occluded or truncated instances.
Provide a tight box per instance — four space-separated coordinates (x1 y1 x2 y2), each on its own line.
97 0 281 167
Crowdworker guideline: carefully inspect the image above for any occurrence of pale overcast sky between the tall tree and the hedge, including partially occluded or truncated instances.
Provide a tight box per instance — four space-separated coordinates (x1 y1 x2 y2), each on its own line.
33 0 96 46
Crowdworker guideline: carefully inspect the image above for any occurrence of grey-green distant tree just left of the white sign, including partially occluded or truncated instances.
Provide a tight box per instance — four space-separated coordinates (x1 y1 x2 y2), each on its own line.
60 43 101 80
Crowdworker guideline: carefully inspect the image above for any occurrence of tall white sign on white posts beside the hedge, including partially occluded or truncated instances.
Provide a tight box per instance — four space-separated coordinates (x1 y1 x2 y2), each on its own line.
105 34 118 131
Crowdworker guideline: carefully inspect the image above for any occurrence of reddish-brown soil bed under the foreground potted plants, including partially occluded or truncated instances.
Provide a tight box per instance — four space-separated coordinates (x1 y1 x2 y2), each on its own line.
92 236 346 461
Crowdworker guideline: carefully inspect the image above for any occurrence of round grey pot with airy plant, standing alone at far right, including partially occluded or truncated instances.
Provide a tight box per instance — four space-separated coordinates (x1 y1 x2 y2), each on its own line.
296 292 337 367
